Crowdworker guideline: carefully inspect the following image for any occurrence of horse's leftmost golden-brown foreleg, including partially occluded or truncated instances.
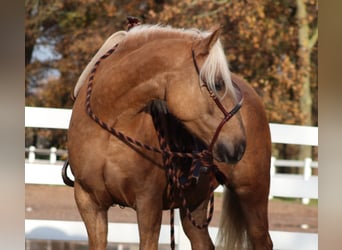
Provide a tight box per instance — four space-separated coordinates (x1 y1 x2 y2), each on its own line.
74 182 108 250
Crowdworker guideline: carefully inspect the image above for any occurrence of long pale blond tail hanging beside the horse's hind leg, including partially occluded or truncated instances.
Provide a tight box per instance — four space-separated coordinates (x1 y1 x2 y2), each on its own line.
216 188 251 250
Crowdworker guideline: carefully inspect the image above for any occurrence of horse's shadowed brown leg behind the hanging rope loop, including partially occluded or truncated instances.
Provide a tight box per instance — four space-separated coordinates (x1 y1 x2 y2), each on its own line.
180 200 215 250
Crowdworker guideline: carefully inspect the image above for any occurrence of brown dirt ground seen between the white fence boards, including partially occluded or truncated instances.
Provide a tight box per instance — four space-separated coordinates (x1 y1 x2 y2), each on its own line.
25 184 318 233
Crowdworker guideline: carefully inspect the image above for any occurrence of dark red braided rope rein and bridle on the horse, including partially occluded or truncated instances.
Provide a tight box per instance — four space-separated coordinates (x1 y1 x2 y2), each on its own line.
85 33 243 249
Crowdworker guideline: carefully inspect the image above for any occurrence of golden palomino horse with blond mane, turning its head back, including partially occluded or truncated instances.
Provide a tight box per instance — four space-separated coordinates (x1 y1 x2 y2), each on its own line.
63 22 272 250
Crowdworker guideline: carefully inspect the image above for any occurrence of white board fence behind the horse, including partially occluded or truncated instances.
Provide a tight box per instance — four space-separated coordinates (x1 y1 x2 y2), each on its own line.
25 107 318 250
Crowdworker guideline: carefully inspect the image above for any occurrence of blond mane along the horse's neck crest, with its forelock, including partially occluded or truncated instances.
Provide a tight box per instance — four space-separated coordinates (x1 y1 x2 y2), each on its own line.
74 25 236 98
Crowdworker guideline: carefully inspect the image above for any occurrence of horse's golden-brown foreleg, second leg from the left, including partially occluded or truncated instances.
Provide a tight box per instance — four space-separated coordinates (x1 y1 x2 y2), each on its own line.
136 196 163 250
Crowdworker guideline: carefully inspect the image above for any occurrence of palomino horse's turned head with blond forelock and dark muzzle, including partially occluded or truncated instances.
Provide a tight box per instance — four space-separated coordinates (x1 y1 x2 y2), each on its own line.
159 26 246 163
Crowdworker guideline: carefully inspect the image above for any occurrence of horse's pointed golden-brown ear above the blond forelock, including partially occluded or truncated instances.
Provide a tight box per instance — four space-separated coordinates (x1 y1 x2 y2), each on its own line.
193 26 221 56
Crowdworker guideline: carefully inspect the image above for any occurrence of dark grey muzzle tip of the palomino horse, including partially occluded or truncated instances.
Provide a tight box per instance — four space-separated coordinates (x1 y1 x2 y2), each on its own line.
214 141 246 163
